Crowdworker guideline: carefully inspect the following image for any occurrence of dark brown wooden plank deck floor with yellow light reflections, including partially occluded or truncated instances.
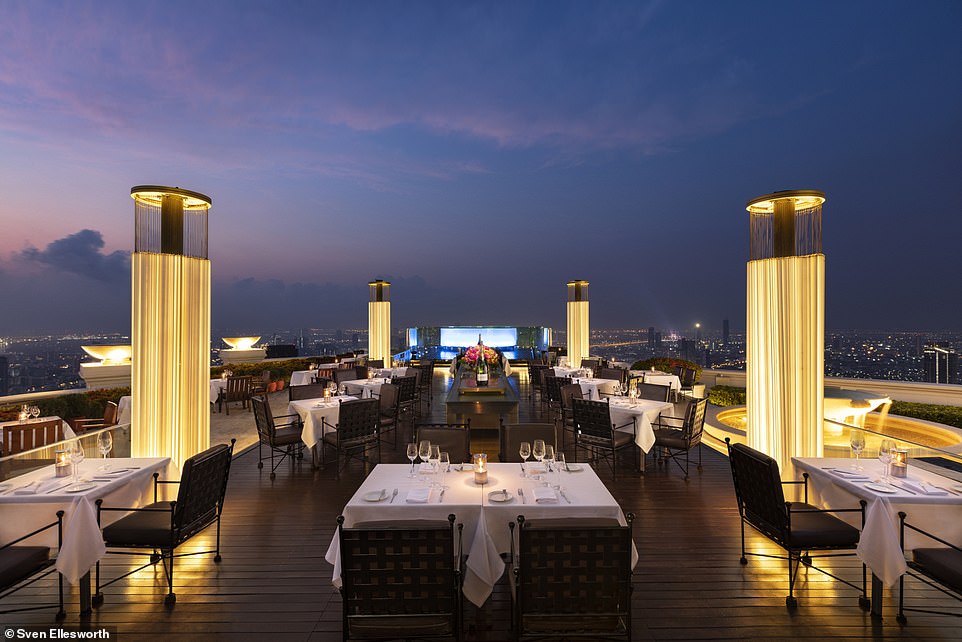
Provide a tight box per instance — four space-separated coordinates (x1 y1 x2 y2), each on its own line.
0 372 962 642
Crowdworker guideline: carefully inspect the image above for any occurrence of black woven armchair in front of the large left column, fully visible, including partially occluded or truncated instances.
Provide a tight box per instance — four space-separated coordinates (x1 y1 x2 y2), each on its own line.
95 439 235 606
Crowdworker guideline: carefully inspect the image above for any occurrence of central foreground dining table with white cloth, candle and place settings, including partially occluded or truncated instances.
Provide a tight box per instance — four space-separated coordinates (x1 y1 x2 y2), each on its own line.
325 462 638 606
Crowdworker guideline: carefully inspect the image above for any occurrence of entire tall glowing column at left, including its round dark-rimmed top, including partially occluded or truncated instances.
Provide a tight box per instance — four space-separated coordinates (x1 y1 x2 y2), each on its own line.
130 185 211 466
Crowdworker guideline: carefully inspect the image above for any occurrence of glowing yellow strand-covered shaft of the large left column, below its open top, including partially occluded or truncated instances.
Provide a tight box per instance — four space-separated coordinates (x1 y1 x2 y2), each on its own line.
131 252 210 466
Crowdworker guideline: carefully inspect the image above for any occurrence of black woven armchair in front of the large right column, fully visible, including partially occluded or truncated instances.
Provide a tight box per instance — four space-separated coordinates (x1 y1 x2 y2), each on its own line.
725 439 869 611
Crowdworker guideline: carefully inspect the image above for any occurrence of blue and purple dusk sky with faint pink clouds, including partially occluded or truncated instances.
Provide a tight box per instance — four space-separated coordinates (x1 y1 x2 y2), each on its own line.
0 0 962 335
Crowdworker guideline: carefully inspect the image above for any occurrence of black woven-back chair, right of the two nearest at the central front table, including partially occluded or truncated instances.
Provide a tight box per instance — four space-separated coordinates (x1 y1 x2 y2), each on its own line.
509 513 634 640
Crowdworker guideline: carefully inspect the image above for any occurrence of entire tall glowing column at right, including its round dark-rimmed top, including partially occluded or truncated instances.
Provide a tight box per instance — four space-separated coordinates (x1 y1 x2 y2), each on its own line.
746 190 825 472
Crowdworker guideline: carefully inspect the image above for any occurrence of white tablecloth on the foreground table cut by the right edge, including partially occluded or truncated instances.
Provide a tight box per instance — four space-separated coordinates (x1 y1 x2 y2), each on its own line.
792 457 962 586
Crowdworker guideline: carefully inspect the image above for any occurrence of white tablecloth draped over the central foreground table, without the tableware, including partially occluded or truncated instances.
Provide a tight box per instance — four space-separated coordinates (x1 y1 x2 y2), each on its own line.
325 463 638 606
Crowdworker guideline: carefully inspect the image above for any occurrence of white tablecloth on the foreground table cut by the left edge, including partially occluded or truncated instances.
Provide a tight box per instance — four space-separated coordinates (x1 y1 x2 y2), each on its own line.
0 457 176 584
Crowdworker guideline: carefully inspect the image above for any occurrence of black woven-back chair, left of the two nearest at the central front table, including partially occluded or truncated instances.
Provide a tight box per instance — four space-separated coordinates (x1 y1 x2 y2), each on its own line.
337 515 463 640
